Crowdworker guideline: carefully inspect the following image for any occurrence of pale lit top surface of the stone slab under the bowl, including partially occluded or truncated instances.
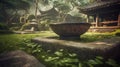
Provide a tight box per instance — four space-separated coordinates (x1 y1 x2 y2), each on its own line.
32 37 120 49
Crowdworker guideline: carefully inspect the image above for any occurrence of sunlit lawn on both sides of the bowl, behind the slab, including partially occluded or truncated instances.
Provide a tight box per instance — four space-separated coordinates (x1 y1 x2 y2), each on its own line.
0 31 115 52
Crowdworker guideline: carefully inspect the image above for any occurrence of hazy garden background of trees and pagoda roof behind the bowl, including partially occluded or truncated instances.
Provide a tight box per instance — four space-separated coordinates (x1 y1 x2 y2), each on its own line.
0 0 95 30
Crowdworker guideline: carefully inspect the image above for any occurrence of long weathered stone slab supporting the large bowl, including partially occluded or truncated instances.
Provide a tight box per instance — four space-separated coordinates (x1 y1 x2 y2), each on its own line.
32 37 120 60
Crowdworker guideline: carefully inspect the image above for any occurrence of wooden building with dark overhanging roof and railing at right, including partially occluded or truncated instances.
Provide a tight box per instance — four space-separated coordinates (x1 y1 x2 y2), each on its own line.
79 0 120 32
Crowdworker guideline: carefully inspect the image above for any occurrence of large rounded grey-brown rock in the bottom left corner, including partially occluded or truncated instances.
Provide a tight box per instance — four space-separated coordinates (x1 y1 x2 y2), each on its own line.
0 50 45 67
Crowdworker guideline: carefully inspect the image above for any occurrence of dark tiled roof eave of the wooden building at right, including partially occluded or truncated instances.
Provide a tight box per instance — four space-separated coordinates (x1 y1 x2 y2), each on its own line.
79 0 120 15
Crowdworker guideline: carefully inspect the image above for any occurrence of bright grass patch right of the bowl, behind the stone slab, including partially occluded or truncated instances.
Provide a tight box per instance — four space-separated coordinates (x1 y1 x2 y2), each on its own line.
79 33 115 42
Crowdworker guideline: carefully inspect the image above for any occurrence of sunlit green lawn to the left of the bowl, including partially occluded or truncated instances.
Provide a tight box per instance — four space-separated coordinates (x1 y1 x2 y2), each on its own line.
0 31 56 53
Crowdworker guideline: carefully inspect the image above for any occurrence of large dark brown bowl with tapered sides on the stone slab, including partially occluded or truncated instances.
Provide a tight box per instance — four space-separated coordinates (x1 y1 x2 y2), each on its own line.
50 23 91 38
